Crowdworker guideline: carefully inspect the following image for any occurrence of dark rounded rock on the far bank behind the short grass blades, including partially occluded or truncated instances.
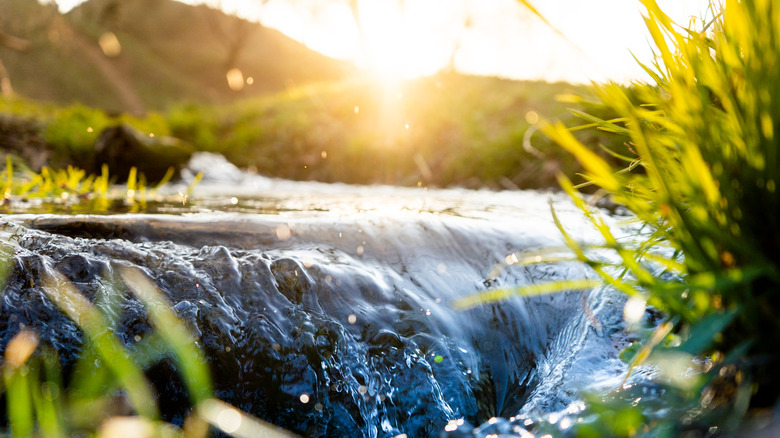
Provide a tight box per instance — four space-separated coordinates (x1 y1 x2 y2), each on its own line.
94 125 193 182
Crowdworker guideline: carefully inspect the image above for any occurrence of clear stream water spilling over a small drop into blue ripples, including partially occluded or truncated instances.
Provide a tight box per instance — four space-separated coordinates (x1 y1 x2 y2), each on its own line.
0 156 626 437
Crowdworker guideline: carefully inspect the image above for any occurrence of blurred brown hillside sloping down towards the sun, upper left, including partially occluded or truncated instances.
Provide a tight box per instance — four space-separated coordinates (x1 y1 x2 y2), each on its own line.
0 0 350 113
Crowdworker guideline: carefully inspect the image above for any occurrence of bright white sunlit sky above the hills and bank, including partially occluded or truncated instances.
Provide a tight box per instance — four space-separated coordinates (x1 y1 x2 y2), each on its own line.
48 0 708 83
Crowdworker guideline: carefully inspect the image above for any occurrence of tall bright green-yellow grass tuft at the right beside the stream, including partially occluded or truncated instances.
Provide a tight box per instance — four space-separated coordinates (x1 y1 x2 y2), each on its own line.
542 0 780 424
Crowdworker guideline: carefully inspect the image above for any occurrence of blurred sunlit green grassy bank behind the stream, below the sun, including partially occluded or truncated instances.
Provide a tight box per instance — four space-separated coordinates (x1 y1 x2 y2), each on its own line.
0 74 614 188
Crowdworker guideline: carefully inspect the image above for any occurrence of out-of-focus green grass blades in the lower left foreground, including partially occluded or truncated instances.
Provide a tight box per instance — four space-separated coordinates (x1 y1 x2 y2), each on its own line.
0 248 293 438
